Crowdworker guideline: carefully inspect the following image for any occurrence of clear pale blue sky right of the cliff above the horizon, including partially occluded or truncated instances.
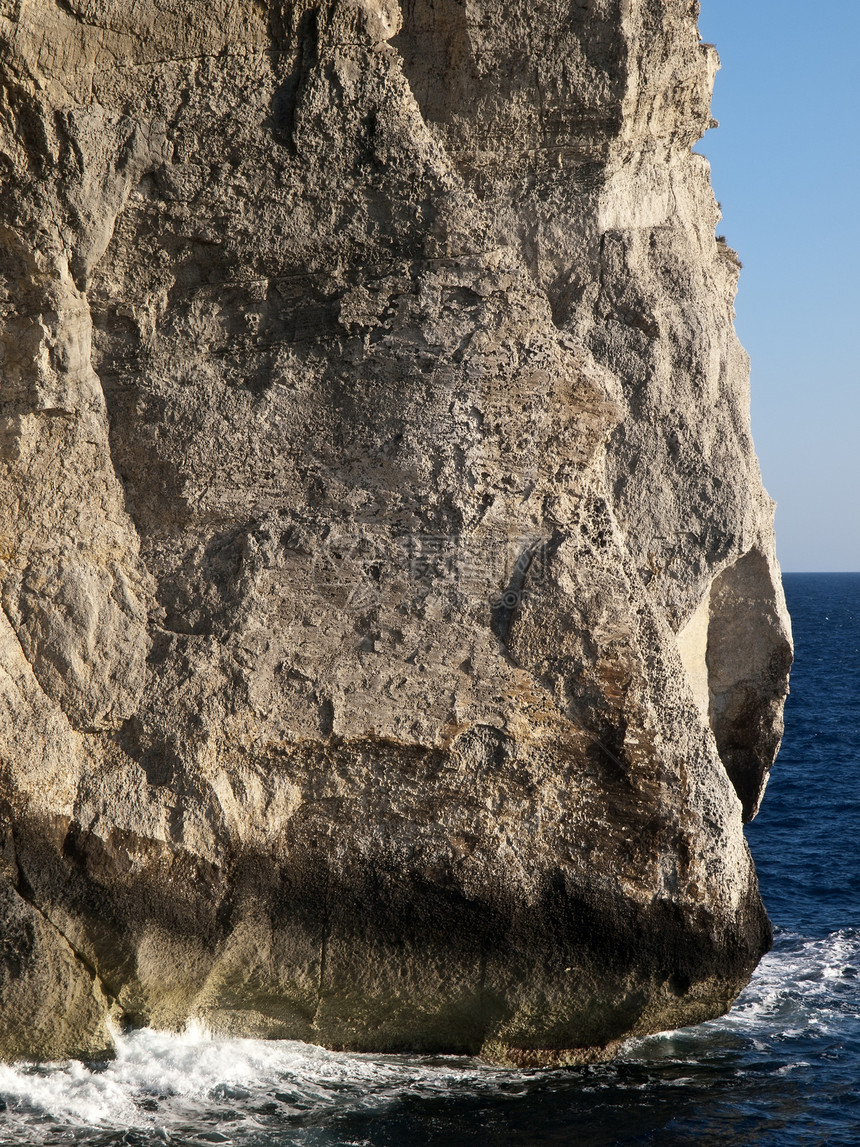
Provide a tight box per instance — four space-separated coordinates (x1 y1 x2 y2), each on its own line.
696 0 860 571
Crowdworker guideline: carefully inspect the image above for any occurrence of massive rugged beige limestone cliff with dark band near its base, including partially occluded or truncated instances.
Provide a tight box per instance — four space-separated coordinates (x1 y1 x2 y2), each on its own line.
0 0 790 1064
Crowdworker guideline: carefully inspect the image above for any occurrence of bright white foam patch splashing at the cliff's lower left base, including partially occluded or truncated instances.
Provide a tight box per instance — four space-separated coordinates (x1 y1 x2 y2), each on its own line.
0 1027 533 1144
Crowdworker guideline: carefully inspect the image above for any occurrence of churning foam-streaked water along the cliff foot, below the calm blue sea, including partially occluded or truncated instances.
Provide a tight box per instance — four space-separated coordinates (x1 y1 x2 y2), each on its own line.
0 929 860 1147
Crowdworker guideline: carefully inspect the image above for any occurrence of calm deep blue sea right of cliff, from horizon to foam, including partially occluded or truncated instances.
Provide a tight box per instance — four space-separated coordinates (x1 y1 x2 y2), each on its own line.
748 574 860 936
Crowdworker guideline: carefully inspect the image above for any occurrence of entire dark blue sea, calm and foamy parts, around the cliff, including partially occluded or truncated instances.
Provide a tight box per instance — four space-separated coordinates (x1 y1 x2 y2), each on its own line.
0 574 860 1147
